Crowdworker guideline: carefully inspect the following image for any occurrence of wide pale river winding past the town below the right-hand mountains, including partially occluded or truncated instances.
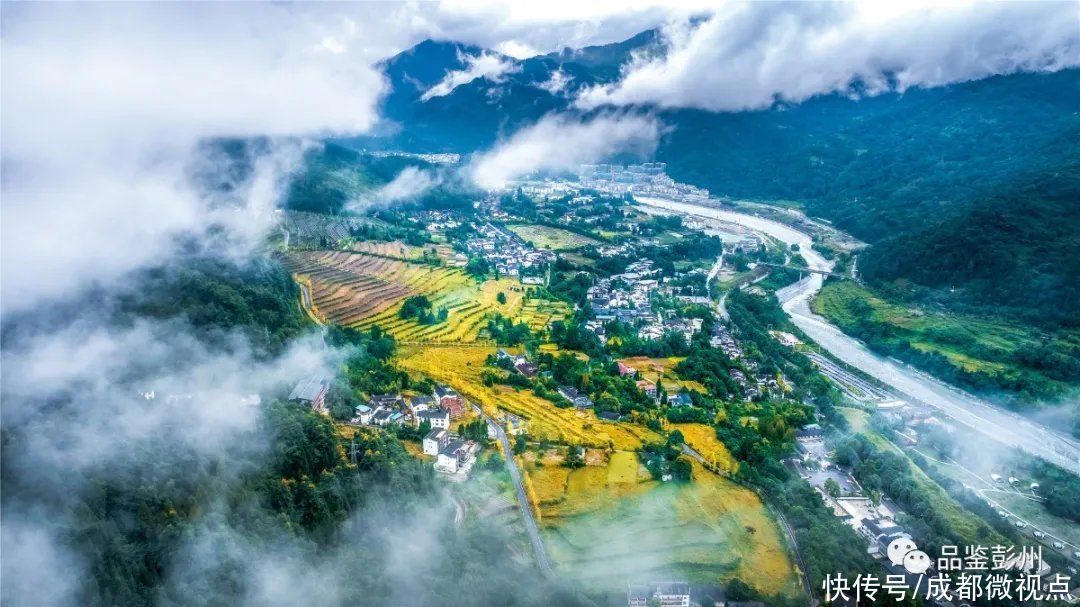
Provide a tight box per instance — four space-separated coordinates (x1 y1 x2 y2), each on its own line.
637 198 1080 474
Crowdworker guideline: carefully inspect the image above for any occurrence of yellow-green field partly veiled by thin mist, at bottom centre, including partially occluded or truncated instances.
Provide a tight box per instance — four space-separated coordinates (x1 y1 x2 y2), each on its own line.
526 451 799 595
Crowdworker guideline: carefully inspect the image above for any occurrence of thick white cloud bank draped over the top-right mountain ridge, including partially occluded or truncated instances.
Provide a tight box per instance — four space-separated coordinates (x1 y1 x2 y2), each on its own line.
577 2 1080 111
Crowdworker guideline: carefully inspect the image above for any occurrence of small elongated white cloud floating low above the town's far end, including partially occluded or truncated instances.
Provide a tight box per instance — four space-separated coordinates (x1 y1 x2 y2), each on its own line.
465 112 661 188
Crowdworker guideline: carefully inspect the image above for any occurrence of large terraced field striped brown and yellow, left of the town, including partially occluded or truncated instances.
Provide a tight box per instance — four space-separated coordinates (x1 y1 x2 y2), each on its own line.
286 243 568 343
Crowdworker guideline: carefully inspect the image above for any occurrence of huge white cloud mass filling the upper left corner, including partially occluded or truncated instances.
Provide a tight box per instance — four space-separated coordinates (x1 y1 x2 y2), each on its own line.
0 3 395 311
